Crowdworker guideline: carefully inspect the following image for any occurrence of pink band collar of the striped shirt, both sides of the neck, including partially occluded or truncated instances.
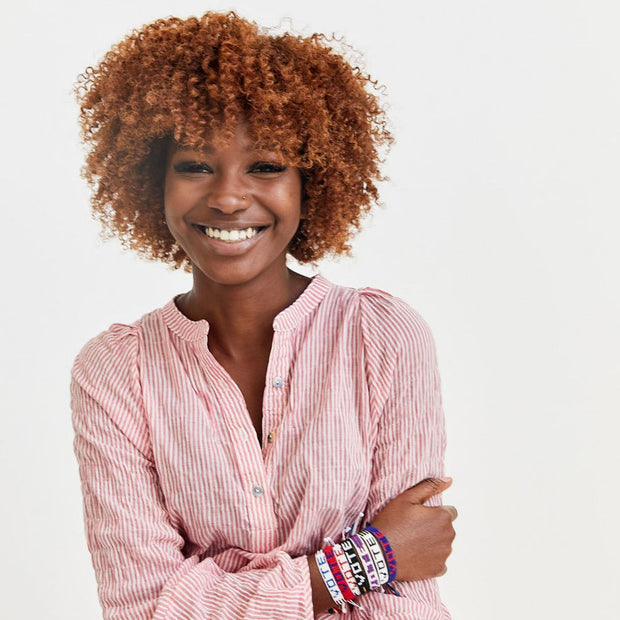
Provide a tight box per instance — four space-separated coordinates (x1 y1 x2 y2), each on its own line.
161 274 333 340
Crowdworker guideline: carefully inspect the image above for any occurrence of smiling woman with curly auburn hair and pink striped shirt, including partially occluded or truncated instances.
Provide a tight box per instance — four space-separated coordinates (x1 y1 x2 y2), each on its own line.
72 13 456 620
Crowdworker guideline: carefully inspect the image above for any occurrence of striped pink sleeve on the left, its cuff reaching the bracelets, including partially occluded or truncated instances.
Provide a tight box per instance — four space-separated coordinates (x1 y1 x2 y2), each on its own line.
71 325 313 620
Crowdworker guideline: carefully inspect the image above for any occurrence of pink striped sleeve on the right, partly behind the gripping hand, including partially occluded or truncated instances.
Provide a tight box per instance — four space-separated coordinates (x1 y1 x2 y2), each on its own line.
360 289 450 620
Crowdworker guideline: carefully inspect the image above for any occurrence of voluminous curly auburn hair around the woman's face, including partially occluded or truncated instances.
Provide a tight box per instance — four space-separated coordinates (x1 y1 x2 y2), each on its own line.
75 12 392 270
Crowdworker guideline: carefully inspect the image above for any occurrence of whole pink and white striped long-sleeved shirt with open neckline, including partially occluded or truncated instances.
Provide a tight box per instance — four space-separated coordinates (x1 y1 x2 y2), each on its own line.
71 275 450 620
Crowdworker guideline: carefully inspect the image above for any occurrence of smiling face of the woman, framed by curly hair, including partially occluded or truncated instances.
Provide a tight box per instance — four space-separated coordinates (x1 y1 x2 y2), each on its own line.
164 124 302 285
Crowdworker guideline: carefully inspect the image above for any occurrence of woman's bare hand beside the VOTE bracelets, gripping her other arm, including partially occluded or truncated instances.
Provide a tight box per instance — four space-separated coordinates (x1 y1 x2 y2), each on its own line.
372 478 457 581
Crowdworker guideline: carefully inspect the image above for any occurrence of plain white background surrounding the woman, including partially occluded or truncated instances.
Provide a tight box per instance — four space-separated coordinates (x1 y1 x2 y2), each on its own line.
0 0 620 620
